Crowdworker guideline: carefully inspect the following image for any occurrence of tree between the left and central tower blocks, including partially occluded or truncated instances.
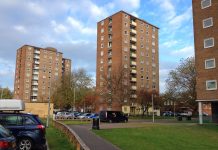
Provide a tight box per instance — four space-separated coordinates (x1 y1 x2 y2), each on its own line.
52 69 93 109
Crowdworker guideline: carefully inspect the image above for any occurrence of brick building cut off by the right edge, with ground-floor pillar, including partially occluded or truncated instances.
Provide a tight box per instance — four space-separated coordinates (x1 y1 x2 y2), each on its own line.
192 0 218 124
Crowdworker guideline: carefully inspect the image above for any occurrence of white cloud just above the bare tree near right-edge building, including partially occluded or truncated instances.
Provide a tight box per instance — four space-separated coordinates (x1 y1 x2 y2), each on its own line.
171 46 194 57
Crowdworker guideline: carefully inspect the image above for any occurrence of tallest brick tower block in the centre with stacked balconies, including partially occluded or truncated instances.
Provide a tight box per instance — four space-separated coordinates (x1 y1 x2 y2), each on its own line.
96 11 159 113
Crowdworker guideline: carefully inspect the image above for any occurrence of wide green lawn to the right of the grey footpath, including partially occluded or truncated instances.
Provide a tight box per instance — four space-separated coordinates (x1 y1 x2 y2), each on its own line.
94 124 218 150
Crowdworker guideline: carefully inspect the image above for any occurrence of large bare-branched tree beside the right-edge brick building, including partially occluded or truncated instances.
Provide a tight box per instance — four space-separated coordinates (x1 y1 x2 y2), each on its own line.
166 57 197 110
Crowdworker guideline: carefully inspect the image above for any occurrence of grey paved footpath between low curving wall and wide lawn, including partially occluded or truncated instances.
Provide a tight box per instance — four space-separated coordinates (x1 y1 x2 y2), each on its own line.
69 125 120 150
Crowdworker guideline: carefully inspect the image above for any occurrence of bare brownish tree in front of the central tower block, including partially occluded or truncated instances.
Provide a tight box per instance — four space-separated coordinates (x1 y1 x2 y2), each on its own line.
100 68 131 107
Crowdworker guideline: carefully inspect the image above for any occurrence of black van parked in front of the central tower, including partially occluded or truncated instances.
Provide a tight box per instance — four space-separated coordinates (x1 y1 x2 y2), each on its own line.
99 111 128 123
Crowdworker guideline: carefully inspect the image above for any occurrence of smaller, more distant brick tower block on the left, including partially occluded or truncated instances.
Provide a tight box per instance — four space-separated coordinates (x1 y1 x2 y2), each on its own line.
14 45 71 102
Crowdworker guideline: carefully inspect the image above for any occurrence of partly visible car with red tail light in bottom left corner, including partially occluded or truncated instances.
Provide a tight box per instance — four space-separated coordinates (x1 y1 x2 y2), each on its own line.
0 125 16 150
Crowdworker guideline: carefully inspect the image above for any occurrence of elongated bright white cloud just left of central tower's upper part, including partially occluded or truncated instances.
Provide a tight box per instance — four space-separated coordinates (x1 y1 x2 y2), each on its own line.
67 17 97 35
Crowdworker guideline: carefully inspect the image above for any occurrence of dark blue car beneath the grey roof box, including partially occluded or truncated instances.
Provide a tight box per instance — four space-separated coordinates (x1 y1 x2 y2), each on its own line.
0 112 47 150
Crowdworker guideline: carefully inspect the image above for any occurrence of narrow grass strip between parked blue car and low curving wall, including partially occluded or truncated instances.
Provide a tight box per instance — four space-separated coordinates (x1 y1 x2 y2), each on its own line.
46 124 75 150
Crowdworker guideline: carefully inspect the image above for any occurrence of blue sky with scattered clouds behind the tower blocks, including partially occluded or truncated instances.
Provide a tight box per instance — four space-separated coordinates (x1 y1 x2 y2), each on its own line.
0 0 194 92
